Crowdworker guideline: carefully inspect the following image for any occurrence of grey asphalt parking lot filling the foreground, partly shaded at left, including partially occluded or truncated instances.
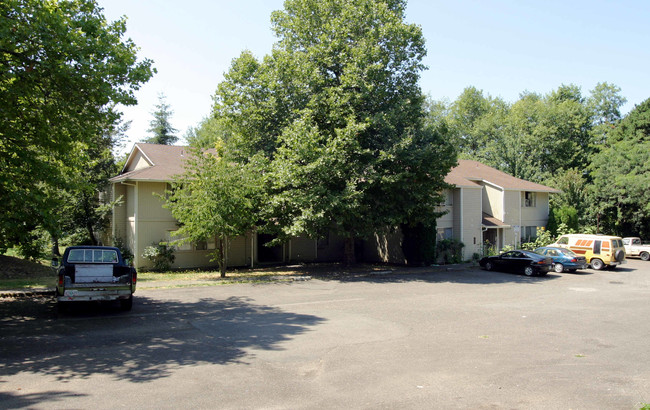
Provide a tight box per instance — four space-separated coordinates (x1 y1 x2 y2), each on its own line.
0 260 650 409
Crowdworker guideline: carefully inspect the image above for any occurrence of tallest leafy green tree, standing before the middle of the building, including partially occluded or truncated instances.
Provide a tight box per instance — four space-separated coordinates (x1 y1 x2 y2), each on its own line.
246 0 455 262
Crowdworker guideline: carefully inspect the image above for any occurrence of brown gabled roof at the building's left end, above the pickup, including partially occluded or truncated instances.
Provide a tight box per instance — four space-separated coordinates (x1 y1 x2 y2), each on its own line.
110 143 191 182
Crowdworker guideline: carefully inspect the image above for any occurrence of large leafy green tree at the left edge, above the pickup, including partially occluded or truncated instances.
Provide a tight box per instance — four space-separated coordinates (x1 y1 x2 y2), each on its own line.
0 0 153 248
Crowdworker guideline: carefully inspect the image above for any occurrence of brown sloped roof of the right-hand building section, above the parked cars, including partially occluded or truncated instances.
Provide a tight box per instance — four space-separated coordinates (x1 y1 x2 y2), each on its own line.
445 159 560 193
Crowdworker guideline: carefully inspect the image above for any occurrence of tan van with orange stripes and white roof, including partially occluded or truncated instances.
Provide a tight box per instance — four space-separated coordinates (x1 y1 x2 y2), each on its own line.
548 234 626 270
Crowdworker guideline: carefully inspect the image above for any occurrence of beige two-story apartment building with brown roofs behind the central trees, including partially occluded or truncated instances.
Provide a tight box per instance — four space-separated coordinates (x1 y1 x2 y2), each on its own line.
109 144 557 268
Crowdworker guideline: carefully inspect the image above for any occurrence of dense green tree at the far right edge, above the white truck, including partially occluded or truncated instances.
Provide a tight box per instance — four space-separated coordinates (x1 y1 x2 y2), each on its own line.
590 99 650 238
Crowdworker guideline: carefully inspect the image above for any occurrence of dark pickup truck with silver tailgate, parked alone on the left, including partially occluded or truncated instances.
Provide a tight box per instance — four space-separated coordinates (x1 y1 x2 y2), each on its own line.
52 246 137 310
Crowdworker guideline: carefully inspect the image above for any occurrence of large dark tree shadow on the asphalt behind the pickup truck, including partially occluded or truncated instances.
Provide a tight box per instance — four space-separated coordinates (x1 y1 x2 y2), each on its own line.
0 297 324 390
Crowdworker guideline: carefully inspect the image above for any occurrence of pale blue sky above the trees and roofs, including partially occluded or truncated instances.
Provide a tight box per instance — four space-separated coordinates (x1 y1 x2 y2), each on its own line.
98 0 650 150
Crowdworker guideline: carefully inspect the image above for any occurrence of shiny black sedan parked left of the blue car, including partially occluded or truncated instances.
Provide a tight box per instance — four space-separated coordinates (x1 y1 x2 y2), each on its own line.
479 249 553 276
